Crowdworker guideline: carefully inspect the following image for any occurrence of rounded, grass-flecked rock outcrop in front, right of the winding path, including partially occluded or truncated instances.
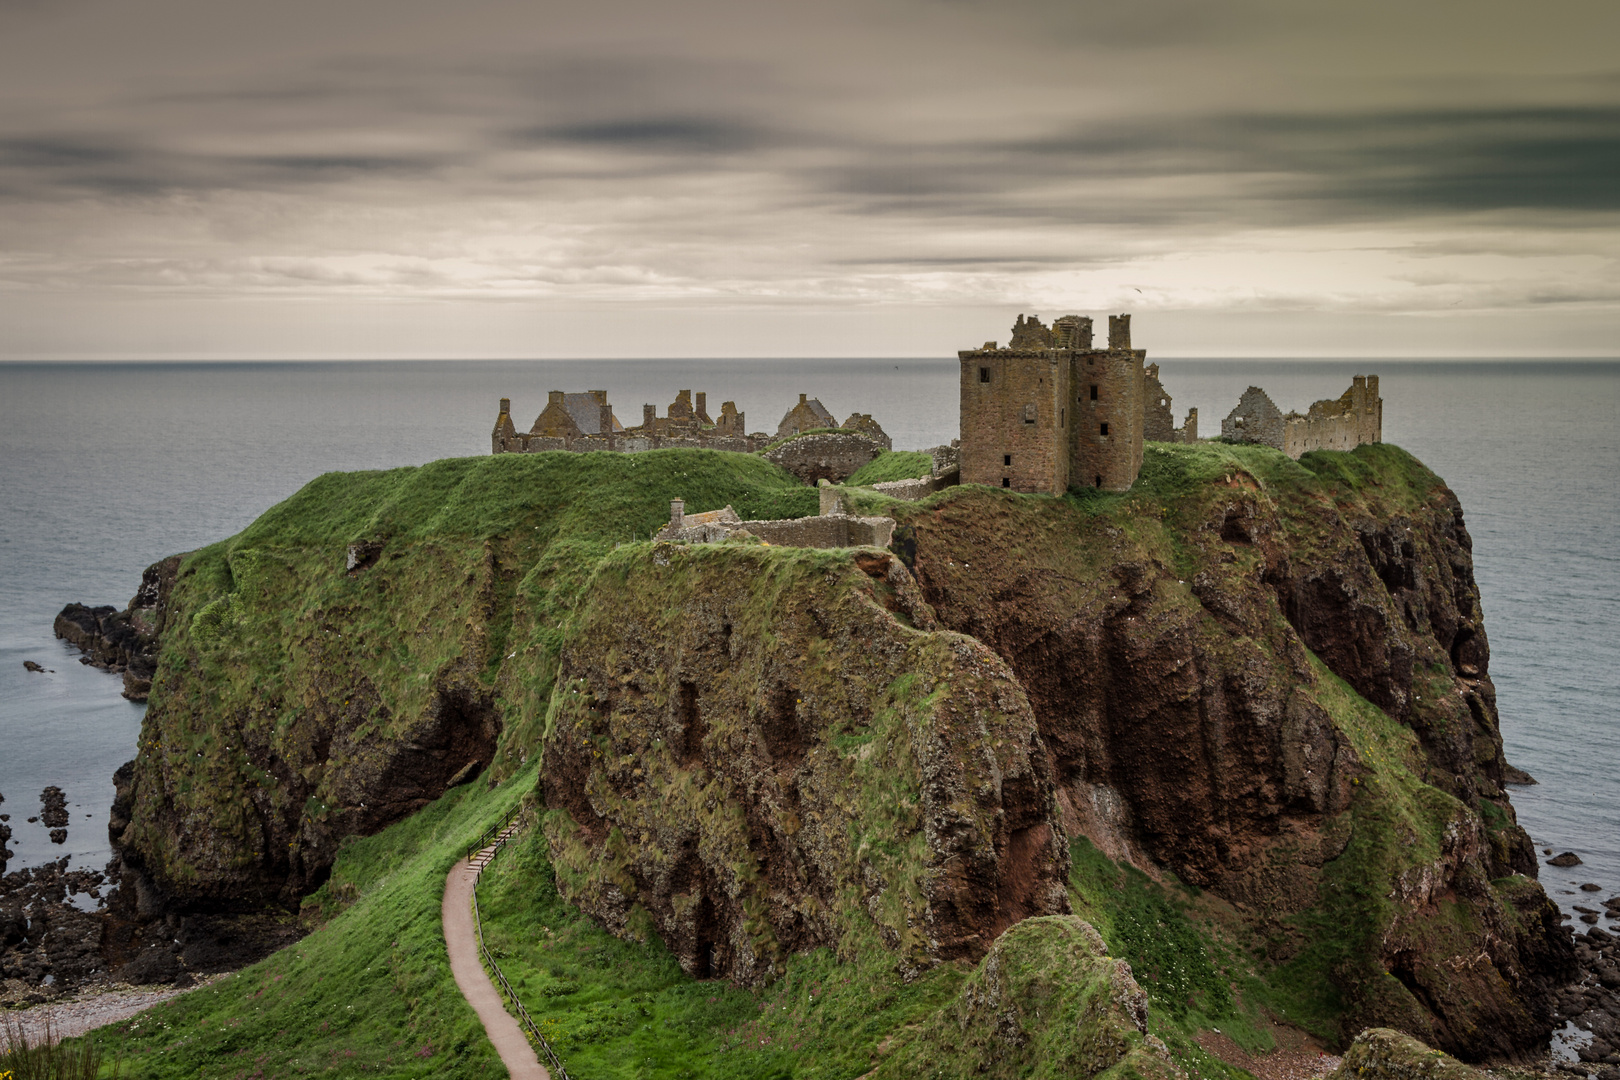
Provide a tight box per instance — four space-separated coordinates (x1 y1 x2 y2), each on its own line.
543 544 1068 981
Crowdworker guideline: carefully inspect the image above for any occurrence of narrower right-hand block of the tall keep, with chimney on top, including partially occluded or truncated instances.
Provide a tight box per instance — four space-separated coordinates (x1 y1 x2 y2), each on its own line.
1069 348 1147 491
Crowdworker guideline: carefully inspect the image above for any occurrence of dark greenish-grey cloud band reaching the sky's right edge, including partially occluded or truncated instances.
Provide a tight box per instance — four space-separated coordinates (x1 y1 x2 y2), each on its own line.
820 105 1620 225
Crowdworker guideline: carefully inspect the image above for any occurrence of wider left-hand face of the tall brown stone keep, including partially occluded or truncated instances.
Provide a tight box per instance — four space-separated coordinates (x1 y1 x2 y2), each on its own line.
957 351 1071 495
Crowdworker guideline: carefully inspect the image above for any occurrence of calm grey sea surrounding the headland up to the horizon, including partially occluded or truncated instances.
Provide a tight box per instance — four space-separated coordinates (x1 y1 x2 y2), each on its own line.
0 359 1620 904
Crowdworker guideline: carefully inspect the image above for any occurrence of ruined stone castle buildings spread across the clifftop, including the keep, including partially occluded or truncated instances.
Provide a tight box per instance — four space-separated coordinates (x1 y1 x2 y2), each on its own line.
491 314 1383 514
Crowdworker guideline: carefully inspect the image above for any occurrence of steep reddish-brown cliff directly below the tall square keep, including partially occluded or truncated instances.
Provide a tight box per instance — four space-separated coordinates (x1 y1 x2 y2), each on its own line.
881 447 1570 1057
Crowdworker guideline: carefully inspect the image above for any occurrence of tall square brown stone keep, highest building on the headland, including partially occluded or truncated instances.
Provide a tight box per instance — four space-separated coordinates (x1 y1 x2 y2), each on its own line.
957 316 1145 495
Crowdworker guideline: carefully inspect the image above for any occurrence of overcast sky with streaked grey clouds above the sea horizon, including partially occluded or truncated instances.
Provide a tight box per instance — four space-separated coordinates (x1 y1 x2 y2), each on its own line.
0 0 1620 359
